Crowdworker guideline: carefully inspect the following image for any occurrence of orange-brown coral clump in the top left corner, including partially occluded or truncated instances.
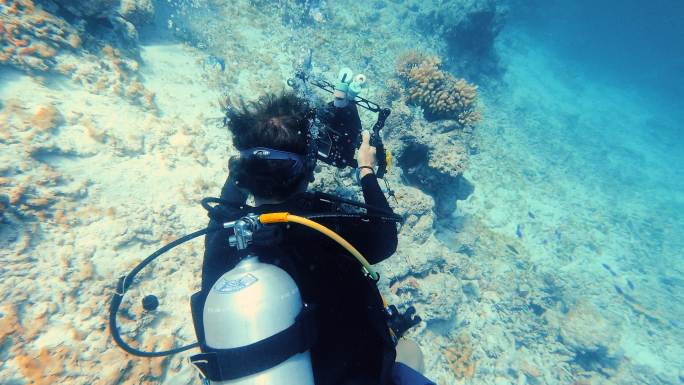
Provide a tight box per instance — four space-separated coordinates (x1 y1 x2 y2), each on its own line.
0 0 81 71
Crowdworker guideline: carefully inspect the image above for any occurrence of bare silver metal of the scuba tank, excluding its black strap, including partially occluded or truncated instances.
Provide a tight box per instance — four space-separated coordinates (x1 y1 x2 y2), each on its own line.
203 256 314 385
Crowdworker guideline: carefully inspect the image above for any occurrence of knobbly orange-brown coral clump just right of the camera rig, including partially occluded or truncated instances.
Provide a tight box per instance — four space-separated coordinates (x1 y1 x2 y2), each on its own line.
396 52 481 127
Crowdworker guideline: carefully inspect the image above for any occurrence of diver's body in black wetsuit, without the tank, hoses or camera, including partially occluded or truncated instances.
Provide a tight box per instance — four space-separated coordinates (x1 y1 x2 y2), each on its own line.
198 88 431 385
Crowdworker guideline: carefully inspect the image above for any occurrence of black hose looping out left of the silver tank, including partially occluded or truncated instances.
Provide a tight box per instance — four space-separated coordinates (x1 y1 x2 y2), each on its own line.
109 225 222 357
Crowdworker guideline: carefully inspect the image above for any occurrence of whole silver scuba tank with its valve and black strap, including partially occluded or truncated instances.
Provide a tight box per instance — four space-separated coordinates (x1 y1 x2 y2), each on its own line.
190 213 316 385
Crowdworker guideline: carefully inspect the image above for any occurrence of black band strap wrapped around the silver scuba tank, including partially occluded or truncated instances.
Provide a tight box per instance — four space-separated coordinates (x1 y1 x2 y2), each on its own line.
190 305 317 381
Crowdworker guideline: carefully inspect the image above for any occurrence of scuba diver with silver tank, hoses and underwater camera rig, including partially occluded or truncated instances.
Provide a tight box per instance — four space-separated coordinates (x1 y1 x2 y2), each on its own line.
110 64 434 385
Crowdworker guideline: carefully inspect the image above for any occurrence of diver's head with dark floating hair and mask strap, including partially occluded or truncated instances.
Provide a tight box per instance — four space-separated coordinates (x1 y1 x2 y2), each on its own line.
225 93 315 202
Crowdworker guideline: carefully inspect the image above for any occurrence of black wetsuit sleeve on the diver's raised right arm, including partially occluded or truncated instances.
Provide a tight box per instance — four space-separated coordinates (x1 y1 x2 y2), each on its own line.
340 174 397 264
